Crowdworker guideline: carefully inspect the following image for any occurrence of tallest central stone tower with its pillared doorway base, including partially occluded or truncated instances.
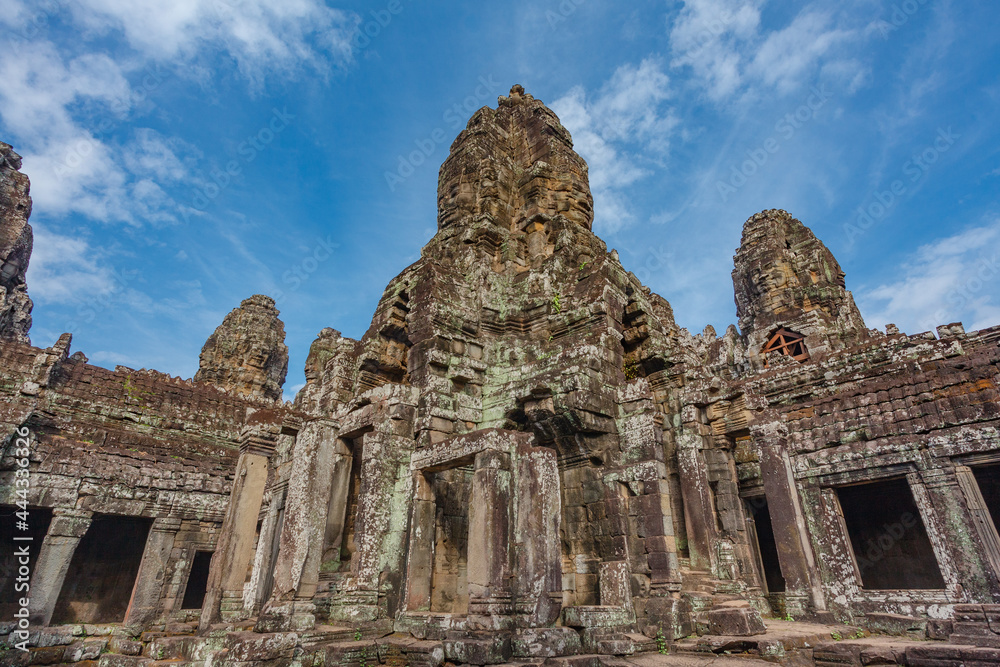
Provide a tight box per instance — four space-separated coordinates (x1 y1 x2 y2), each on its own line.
243 86 685 641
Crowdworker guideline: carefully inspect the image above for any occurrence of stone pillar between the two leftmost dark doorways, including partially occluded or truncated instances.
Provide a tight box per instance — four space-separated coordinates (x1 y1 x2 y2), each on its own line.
28 508 94 626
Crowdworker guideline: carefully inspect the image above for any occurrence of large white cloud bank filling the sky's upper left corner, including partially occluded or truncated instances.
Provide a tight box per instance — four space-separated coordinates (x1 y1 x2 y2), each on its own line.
0 0 358 224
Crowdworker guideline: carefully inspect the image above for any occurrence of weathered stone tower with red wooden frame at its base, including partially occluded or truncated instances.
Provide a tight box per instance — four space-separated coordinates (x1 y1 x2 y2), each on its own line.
733 209 868 368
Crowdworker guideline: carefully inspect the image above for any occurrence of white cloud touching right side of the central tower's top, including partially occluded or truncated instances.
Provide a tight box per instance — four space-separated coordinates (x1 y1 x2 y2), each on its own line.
550 60 677 233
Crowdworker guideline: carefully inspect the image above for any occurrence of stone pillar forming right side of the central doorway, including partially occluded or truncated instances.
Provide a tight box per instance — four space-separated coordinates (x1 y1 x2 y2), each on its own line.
469 449 513 629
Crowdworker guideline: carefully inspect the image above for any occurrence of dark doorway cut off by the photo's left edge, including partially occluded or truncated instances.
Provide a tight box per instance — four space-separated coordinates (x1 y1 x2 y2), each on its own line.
0 505 52 619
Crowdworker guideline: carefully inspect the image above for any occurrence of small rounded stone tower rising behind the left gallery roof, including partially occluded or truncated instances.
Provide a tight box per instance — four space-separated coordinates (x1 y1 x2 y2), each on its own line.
194 294 288 401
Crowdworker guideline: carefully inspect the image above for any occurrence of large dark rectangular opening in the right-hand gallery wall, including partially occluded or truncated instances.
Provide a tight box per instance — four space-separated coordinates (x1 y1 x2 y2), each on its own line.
837 479 944 590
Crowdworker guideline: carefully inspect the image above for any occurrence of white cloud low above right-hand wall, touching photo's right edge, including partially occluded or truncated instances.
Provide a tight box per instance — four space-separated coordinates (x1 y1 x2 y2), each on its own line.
857 220 1000 333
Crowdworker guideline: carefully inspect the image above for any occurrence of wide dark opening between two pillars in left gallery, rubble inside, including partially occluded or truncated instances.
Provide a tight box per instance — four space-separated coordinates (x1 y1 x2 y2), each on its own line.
52 515 153 625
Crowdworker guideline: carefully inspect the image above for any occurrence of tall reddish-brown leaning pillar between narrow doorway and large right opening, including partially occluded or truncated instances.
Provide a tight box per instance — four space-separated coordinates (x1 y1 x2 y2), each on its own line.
755 434 826 616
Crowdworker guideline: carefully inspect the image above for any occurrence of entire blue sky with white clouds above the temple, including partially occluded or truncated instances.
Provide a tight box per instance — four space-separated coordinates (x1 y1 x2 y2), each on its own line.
0 0 1000 396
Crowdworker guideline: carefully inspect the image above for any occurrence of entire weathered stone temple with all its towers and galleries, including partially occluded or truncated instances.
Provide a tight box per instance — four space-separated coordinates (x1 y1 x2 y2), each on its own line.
0 86 1000 667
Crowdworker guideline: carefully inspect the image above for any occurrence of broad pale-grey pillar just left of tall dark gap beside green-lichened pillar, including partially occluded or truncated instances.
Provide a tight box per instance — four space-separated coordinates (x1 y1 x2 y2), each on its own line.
258 419 338 632
